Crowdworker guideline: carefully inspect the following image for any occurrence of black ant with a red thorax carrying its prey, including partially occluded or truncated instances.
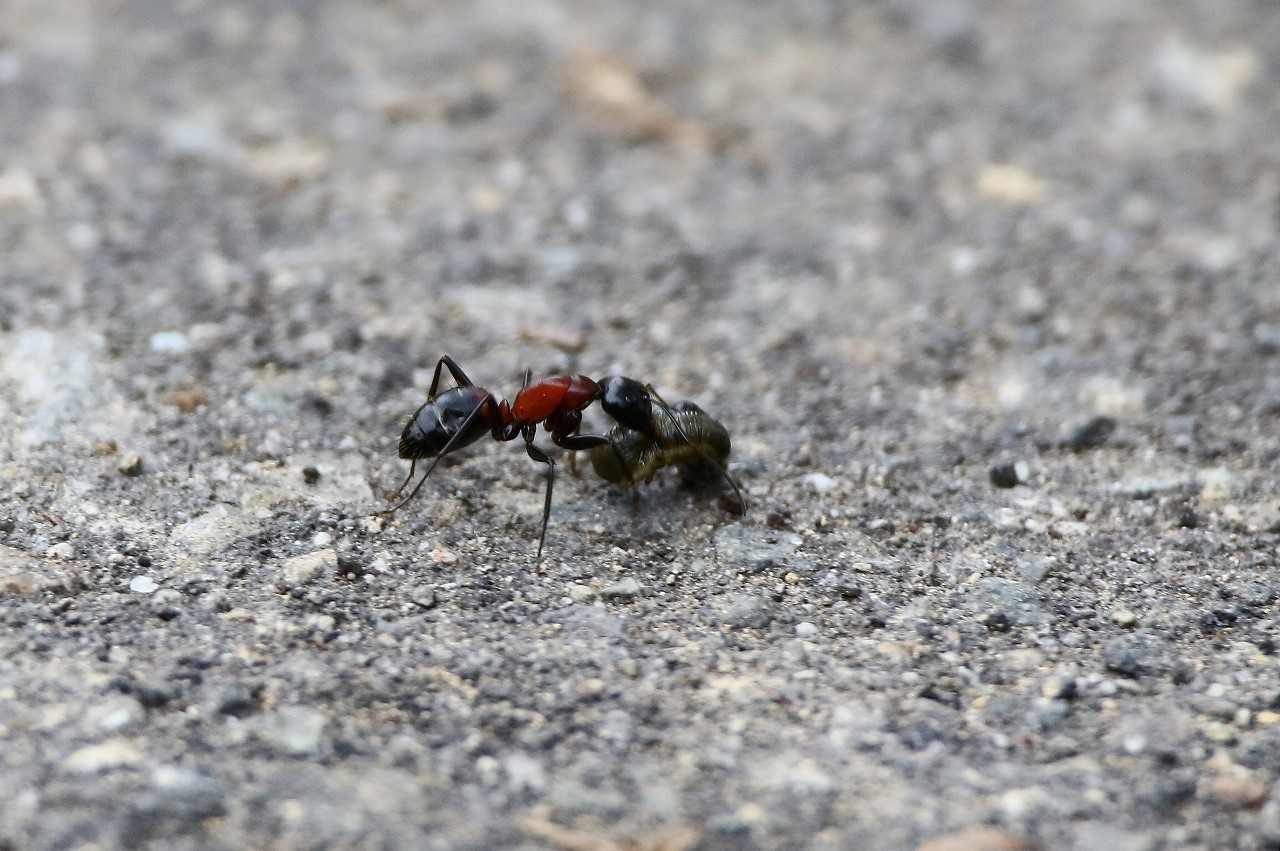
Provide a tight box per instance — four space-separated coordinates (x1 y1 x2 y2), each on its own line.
381 354 660 563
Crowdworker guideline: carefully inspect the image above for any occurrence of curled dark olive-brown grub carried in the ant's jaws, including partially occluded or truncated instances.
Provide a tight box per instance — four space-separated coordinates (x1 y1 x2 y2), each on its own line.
591 396 746 516
